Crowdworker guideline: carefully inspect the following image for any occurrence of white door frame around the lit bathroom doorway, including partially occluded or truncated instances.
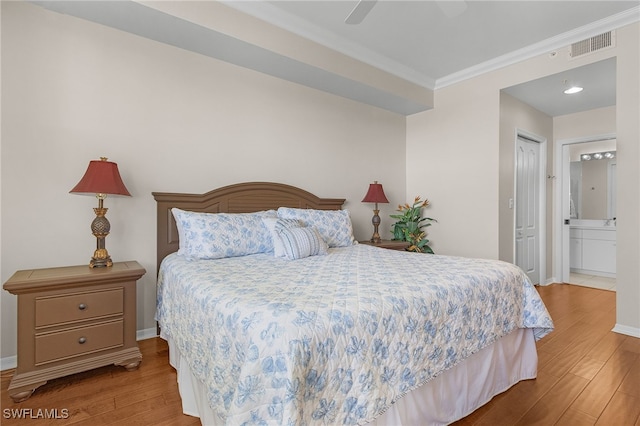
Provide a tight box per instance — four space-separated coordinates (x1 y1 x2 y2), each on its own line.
552 133 616 283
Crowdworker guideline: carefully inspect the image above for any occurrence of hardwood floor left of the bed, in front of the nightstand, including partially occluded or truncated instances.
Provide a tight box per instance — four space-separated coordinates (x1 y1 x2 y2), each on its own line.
0 338 200 426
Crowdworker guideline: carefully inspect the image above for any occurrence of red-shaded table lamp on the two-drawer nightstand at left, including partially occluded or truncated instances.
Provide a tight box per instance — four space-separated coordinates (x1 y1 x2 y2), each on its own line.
69 157 131 268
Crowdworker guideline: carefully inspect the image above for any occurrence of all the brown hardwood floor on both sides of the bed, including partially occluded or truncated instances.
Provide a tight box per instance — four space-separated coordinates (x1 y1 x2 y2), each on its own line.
0 284 640 426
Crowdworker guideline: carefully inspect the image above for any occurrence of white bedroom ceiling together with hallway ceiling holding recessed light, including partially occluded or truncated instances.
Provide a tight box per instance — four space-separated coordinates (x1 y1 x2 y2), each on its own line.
228 0 640 116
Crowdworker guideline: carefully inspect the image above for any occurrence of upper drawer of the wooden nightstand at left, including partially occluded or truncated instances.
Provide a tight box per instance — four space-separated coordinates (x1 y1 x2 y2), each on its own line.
36 288 124 328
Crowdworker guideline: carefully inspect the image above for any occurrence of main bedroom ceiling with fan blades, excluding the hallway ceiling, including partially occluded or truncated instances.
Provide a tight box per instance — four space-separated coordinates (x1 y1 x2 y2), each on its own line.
232 0 640 88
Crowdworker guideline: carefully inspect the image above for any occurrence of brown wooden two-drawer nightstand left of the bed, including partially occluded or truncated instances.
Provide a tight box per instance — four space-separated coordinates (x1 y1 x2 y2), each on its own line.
3 261 146 402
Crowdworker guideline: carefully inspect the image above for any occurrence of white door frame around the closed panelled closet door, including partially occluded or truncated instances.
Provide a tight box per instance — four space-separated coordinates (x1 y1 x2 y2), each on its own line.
511 128 553 285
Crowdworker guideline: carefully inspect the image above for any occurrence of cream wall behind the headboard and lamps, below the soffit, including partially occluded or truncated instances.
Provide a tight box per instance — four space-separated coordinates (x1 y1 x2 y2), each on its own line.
0 2 406 358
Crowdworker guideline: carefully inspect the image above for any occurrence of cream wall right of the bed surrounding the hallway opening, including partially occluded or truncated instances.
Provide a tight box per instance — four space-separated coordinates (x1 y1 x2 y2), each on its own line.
407 23 640 335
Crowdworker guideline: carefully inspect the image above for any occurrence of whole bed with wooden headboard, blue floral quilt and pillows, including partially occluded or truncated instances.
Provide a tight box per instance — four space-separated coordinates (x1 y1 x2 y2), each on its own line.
153 182 553 425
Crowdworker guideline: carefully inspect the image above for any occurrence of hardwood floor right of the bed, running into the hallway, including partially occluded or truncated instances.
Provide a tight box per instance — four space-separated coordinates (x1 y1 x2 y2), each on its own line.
455 284 640 426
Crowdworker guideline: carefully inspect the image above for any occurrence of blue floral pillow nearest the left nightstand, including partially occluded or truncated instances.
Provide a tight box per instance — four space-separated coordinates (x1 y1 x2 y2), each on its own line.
171 208 277 259
